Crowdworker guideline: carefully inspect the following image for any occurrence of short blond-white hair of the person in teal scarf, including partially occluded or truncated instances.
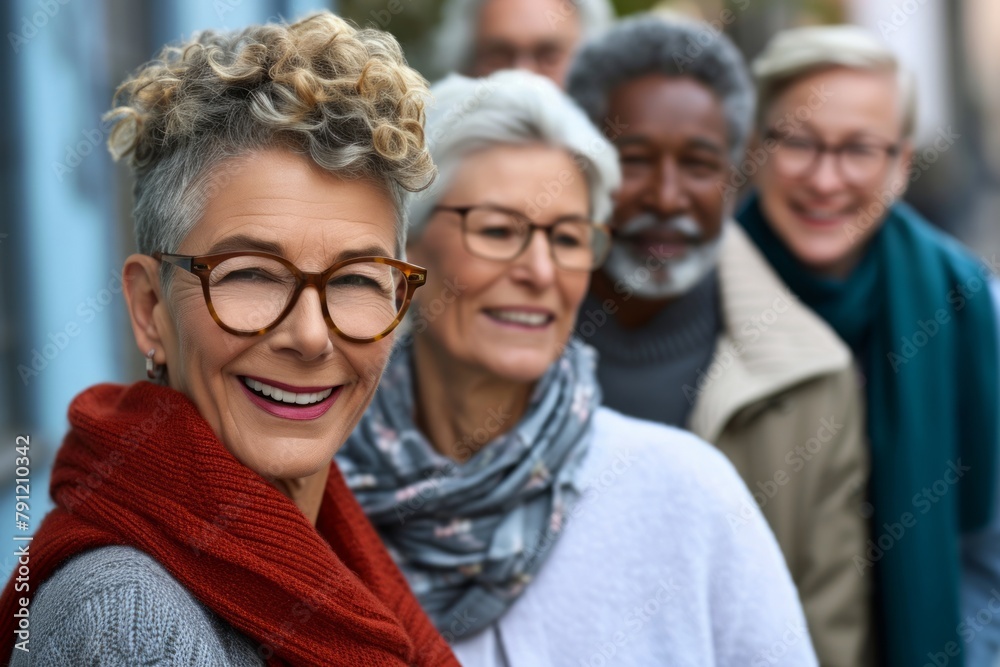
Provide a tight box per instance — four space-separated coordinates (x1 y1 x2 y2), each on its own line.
753 25 917 139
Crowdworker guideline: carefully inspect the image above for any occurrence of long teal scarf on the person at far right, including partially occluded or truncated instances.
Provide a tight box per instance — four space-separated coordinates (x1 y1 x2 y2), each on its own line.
737 194 1000 667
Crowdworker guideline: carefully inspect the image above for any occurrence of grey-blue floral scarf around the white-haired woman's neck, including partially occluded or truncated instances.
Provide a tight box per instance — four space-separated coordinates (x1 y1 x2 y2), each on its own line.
337 340 601 642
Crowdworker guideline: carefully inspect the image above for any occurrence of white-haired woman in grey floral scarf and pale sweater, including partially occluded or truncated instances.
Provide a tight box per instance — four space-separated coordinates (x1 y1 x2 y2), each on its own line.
338 72 816 667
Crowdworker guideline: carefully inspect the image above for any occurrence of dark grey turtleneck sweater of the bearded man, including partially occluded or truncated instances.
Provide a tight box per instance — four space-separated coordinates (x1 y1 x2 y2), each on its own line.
576 271 722 427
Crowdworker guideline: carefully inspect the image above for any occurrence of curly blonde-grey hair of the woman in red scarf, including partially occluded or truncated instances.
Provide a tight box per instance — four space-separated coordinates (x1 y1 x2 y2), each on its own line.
106 12 435 264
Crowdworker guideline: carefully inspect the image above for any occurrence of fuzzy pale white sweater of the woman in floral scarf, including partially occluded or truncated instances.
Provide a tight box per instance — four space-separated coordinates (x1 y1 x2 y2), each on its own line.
454 408 816 667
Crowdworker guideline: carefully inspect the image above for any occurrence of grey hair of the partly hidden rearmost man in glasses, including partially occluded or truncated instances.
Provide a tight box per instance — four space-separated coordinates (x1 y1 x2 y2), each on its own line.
434 0 615 74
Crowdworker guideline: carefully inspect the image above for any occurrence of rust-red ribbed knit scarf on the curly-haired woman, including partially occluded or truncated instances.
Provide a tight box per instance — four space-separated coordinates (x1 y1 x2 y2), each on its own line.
0 382 458 667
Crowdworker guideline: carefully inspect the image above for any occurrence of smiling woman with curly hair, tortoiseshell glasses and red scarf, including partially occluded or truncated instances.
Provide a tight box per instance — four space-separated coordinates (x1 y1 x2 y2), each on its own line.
0 13 457 667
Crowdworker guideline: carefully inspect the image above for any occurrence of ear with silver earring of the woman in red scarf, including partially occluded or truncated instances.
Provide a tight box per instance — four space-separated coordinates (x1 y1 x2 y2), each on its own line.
122 255 171 365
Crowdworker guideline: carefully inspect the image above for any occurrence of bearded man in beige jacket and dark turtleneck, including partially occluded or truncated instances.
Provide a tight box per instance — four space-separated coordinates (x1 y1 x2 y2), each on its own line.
567 15 871 667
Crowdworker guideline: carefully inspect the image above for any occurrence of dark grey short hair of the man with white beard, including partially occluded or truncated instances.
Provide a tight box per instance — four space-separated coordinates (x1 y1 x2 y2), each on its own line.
566 13 754 163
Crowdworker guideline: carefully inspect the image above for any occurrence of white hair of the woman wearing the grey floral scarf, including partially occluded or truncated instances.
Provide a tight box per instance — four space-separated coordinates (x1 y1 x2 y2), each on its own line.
409 70 621 236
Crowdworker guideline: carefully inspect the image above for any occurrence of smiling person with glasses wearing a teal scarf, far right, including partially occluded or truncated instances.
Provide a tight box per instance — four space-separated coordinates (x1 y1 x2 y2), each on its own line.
739 26 1000 667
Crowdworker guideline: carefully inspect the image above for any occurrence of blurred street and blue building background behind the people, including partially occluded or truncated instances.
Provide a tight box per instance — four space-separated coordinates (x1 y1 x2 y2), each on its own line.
0 0 1000 577
